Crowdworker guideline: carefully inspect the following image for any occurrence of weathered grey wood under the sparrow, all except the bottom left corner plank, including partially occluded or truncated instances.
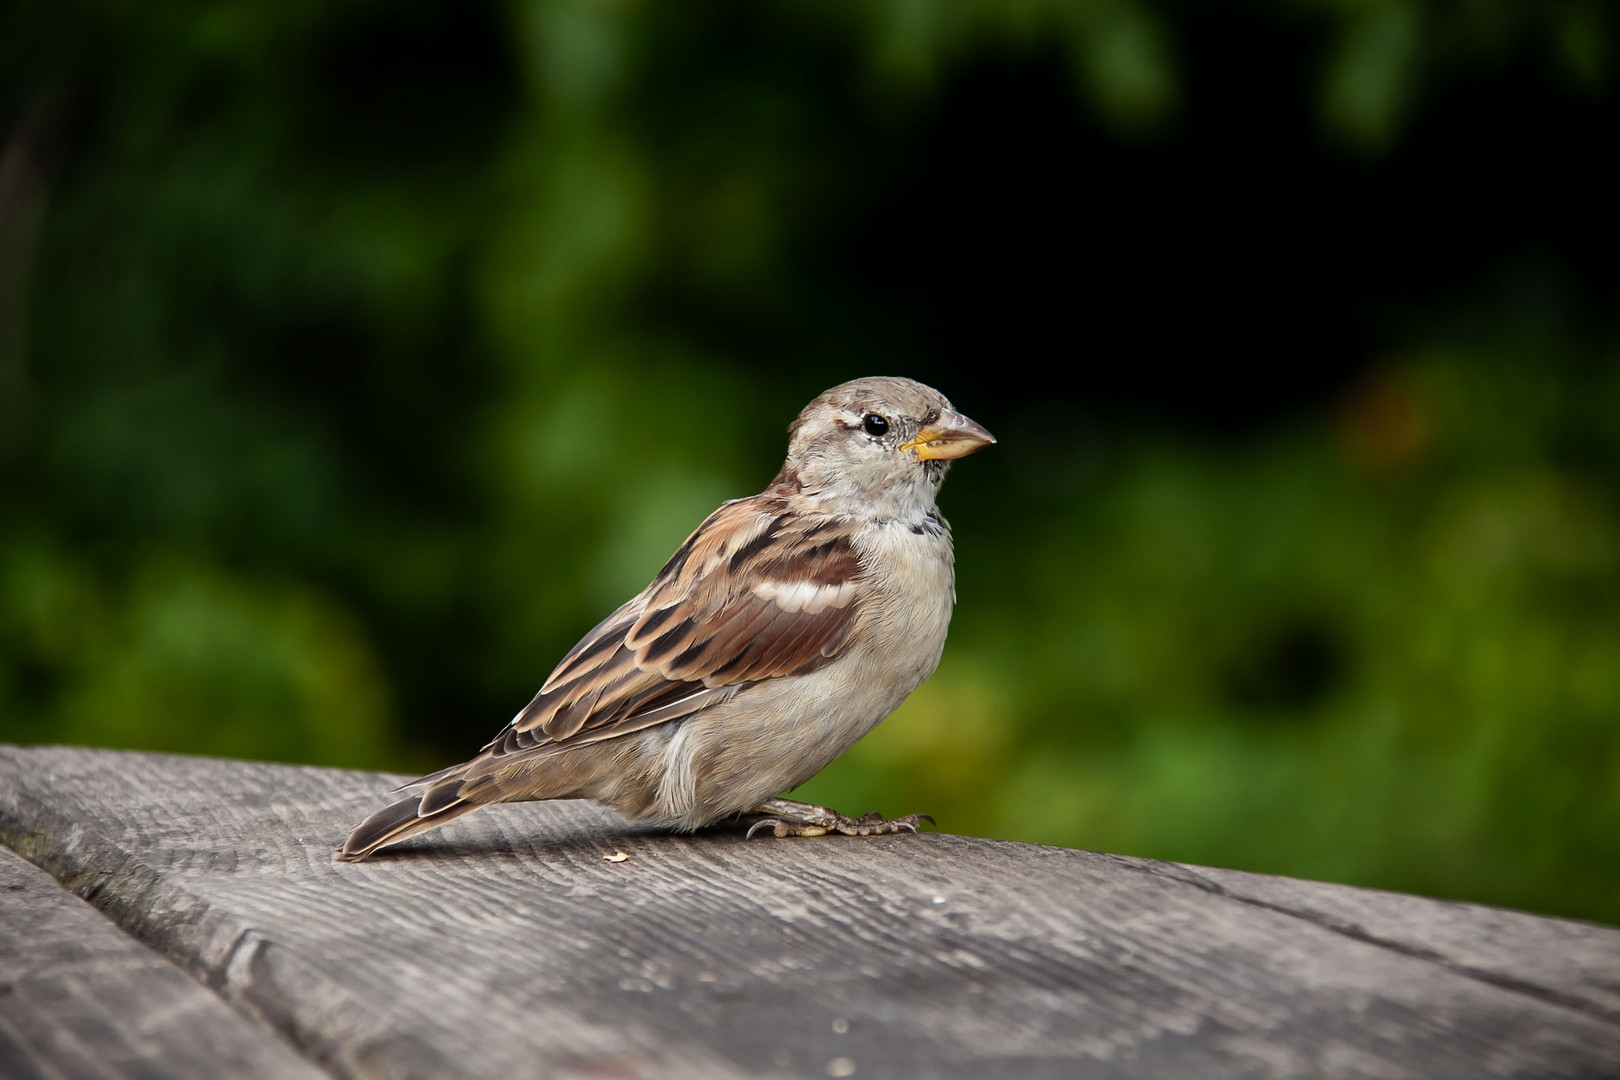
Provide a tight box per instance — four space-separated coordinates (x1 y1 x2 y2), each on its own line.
0 748 1620 1078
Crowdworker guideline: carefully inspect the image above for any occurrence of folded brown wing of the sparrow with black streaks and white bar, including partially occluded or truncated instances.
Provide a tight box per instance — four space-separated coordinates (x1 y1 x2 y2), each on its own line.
465 497 862 780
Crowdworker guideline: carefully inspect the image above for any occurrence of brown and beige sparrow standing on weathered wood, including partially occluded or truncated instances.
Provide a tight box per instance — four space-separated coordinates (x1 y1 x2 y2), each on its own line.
337 377 995 861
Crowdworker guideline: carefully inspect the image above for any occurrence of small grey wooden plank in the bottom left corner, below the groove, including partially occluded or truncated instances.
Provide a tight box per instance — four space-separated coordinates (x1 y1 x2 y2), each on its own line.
0 848 326 1080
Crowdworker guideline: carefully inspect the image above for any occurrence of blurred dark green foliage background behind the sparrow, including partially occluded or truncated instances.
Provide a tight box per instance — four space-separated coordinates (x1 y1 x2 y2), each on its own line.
0 0 1620 921
